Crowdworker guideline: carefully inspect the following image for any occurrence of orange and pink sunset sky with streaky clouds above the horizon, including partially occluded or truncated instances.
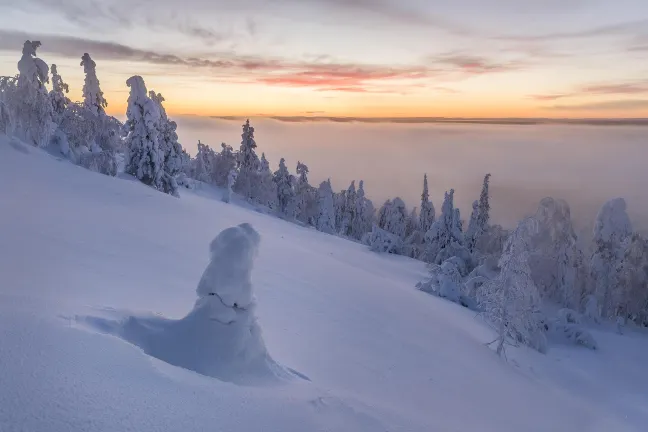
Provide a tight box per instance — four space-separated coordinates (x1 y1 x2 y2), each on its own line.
0 0 648 117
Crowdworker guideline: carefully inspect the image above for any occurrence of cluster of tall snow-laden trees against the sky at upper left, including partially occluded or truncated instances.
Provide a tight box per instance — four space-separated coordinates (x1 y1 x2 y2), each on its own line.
0 41 189 194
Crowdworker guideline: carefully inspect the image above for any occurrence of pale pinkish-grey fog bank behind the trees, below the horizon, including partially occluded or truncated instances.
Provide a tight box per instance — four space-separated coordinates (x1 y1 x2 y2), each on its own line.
175 116 648 235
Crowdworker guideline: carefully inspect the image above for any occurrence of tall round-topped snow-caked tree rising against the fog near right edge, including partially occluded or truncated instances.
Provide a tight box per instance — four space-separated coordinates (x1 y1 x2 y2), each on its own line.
590 198 632 318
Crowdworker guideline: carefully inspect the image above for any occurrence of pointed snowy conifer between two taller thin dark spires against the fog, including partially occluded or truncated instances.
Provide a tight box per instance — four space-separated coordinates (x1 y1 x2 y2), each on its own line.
425 189 472 267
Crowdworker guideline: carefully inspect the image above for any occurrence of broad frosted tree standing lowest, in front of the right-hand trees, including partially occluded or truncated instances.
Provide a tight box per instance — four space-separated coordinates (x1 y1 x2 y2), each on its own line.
478 218 547 355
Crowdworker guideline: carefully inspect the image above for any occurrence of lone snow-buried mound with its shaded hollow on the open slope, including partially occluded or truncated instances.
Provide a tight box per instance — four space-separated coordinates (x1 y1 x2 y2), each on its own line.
77 223 304 385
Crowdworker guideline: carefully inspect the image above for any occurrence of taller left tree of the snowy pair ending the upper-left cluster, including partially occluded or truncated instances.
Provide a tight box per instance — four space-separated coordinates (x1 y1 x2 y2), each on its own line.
124 75 172 193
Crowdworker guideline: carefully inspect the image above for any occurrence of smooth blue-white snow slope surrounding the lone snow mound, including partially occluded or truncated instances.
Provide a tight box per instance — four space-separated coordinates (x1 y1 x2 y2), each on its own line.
0 133 648 432
